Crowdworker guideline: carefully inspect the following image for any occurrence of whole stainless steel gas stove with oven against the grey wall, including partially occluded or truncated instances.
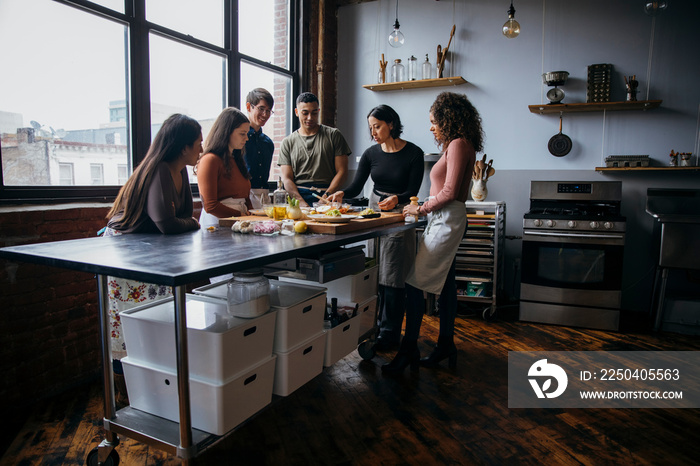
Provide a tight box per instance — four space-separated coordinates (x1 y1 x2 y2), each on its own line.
520 181 625 330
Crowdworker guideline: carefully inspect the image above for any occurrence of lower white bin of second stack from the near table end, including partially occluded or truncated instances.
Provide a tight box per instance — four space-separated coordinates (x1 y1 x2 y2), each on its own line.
274 330 326 396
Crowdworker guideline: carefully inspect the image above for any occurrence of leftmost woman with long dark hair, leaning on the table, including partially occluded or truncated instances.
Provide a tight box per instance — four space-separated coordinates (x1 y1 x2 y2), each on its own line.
104 114 202 404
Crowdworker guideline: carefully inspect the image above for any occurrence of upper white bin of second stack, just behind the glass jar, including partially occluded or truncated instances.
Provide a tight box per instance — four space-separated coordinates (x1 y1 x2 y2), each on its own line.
192 280 326 353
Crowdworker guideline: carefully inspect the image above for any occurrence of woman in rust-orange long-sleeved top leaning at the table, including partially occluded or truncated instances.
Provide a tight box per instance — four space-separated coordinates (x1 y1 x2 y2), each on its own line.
195 107 253 228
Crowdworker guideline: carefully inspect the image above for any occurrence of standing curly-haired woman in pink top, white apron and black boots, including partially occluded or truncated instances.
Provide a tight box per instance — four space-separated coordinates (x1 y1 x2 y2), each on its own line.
382 92 484 374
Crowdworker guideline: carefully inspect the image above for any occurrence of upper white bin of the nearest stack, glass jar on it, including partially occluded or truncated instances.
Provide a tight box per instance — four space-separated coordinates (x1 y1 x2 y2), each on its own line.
120 294 276 383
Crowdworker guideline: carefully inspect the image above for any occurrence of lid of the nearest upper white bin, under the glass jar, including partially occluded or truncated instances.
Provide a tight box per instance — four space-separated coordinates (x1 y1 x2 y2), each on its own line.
120 296 250 333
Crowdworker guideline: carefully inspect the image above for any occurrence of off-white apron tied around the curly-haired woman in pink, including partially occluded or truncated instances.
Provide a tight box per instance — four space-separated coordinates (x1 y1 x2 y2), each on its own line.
406 201 467 295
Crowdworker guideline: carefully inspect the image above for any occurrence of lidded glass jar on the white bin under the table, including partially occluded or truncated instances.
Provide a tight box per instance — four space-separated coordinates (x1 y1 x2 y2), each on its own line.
228 269 270 318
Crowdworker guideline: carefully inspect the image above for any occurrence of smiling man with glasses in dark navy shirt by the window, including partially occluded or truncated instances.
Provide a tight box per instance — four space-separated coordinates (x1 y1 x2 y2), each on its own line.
244 87 275 209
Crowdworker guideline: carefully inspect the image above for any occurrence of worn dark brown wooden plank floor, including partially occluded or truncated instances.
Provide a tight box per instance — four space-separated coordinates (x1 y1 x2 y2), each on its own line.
0 306 700 466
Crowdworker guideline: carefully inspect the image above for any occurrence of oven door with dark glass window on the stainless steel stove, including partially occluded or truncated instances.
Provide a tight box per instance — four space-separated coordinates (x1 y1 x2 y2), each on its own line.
520 229 625 308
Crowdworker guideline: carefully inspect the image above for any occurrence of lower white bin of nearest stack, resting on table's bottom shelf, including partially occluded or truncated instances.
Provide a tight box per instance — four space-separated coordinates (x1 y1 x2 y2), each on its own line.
122 354 276 435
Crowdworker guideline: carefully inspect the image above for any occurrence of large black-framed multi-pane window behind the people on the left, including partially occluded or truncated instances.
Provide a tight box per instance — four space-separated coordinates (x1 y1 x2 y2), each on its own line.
0 0 299 200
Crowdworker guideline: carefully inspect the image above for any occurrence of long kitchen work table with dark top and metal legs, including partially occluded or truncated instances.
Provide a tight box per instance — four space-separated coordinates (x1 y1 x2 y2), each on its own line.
0 222 425 464
